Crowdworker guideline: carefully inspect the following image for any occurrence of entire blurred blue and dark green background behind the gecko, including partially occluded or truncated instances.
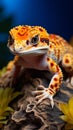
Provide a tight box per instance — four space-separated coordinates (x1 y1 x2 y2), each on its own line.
0 0 73 68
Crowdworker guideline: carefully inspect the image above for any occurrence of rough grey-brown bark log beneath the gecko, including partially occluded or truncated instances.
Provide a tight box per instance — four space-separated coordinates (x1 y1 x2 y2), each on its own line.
0 69 73 130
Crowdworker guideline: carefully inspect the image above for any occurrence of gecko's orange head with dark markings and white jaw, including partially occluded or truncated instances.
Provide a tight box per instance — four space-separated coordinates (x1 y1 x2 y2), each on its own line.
7 26 49 55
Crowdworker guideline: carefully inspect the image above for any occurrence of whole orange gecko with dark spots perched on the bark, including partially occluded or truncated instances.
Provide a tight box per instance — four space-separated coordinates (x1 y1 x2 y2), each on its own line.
7 26 73 107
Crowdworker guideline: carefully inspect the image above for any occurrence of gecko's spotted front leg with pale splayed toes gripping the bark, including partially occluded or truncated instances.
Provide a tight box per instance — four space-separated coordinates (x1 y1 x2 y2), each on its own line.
33 58 63 108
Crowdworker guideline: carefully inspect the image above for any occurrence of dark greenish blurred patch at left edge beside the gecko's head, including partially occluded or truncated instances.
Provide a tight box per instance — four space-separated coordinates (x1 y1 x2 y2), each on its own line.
0 7 13 69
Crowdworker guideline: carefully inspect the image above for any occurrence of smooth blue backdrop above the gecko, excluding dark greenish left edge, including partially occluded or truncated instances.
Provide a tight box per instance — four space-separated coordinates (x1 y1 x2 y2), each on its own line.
0 0 73 40
